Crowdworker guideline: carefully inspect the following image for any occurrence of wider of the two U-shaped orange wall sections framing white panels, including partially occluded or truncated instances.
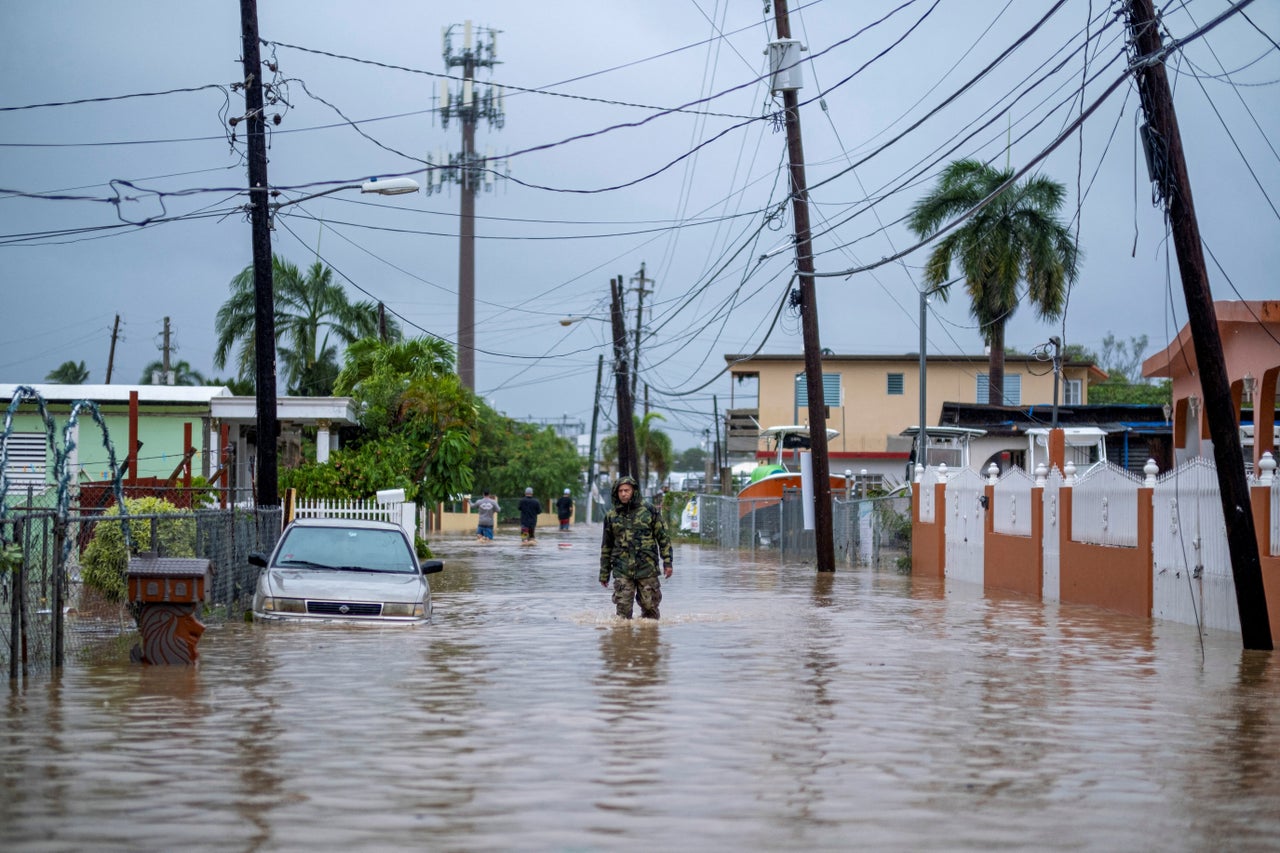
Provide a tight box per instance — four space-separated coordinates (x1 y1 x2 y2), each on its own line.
1059 487 1152 619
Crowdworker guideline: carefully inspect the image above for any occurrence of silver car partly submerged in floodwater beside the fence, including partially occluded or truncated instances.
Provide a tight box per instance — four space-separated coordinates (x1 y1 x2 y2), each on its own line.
248 519 444 625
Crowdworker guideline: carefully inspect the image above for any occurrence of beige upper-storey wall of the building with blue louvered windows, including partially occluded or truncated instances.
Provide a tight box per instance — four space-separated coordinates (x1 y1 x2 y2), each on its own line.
728 356 1103 453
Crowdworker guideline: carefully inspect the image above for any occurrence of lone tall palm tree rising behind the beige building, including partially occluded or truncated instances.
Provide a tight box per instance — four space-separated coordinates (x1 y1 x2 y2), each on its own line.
908 160 1080 403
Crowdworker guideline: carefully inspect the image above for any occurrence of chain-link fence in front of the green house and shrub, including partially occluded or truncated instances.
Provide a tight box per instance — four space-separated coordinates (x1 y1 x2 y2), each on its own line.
0 500 280 680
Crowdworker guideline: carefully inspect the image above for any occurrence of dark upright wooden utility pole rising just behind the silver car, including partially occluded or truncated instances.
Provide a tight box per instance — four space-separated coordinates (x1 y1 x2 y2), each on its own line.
241 0 280 507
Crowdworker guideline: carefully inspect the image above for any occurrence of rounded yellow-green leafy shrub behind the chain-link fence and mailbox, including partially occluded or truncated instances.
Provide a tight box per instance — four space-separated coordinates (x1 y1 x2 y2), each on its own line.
81 497 196 602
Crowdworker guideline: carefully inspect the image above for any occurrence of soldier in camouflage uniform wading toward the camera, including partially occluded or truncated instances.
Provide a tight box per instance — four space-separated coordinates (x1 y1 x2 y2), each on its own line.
600 476 672 619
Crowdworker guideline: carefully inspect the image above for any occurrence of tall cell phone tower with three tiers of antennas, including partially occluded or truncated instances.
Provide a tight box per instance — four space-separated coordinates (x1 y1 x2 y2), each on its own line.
426 20 506 391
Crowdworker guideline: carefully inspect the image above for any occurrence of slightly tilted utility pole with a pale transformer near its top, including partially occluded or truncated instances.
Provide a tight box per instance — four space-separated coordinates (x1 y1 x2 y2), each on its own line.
769 0 836 571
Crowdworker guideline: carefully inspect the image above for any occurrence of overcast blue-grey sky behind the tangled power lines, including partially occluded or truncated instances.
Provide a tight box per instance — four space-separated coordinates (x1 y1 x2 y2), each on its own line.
0 0 1280 447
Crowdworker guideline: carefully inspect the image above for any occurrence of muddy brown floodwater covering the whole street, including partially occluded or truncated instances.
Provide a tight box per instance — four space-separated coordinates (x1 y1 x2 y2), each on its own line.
0 526 1280 850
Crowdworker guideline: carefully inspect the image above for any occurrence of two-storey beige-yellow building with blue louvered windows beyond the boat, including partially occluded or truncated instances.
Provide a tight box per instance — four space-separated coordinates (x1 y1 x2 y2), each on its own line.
724 353 1106 478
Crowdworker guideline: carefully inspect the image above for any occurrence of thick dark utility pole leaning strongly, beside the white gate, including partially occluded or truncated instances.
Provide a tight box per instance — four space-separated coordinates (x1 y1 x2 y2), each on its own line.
1129 0 1272 649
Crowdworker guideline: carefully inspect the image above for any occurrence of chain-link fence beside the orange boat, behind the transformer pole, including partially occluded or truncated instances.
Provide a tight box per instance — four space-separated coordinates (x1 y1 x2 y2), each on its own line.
698 489 911 567
